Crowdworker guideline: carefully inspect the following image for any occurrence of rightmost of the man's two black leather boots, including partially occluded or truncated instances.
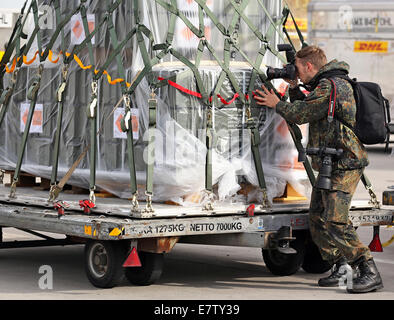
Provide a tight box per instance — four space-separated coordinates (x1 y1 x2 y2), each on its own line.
347 258 383 293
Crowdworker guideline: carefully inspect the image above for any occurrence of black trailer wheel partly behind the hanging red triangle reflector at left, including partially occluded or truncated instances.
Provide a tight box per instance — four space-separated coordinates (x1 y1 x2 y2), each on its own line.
124 251 164 286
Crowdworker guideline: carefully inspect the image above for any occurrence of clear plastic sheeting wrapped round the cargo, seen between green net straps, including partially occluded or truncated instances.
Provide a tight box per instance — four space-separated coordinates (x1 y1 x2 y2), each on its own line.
0 0 309 206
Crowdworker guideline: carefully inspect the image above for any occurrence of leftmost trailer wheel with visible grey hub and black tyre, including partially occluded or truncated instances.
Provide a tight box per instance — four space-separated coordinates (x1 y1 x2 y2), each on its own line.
85 240 125 288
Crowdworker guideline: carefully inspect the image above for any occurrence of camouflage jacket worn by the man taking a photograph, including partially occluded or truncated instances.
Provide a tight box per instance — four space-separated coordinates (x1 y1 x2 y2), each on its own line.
276 60 369 175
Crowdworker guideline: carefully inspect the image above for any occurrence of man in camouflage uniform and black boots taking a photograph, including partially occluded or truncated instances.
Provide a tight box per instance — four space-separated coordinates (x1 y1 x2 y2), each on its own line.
255 46 383 293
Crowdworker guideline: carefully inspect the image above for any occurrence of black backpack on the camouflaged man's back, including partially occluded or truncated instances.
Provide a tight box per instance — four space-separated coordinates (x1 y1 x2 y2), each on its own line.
330 76 391 150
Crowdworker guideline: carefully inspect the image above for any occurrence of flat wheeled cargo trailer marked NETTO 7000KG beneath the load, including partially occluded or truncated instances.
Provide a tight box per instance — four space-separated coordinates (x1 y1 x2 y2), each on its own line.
0 186 394 288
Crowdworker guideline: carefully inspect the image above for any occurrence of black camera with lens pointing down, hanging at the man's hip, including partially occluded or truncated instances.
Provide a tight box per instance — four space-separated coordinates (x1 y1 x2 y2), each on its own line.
306 147 343 190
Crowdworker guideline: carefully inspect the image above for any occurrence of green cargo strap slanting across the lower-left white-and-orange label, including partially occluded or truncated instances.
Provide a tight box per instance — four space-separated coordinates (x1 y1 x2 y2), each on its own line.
9 65 43 198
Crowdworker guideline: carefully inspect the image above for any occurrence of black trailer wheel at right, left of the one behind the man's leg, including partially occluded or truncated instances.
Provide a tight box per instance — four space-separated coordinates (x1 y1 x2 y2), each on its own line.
262 237 305 276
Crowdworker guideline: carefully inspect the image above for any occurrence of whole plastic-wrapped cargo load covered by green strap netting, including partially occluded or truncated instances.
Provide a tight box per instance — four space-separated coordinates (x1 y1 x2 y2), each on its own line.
0 0 309 211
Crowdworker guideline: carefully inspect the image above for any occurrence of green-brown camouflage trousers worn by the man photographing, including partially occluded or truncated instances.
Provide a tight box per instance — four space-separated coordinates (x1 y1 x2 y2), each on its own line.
309 170 372 265
